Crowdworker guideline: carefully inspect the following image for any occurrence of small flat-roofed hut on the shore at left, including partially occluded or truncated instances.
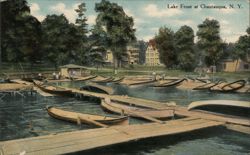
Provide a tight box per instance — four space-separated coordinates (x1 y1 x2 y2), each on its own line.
60 64 90 77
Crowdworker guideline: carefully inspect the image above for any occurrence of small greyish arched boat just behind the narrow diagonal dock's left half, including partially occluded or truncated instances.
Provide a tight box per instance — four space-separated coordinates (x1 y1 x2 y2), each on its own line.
80 82 114 94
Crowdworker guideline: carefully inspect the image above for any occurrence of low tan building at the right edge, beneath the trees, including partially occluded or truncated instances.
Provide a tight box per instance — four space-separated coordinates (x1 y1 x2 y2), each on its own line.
219 59 250 72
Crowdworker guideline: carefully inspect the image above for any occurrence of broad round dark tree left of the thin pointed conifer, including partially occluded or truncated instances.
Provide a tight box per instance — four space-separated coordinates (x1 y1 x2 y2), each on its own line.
42 14 82 68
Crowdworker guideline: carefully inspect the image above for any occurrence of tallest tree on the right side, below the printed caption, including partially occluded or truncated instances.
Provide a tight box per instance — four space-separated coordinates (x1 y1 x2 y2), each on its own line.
197 19 223 66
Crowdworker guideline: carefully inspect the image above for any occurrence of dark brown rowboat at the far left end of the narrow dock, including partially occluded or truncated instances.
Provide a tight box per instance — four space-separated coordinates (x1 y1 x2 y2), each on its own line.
33 80 73 96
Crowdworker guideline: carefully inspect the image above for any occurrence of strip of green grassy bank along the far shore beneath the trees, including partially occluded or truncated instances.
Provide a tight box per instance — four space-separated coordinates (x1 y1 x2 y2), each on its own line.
0 63 250 80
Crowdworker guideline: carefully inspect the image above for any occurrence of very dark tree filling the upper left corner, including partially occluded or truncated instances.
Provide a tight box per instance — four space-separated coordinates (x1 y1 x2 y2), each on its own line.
1 0 41 63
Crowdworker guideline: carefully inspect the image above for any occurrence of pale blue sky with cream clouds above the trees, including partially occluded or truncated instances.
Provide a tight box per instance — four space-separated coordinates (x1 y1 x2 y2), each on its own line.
28 0 250 42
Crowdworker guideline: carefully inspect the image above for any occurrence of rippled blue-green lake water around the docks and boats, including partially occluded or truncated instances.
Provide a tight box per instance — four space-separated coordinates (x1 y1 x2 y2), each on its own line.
0 82 250 155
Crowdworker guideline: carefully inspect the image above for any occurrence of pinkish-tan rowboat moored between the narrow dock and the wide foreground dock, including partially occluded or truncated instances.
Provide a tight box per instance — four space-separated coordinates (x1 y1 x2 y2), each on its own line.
101 99 174 119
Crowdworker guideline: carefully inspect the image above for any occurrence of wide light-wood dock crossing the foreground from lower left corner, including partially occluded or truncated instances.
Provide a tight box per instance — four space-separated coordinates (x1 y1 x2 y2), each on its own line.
0 118 223 155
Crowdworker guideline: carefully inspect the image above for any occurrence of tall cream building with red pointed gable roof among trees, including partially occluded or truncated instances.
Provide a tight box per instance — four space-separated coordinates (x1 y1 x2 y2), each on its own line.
145 39 162 66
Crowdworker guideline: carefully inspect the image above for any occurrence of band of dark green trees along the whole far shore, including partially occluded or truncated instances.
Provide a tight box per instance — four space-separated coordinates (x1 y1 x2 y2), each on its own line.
0 0 250 71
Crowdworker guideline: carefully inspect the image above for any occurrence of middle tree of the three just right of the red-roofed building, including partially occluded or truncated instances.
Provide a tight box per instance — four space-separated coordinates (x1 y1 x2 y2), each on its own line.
174 25 196 71
